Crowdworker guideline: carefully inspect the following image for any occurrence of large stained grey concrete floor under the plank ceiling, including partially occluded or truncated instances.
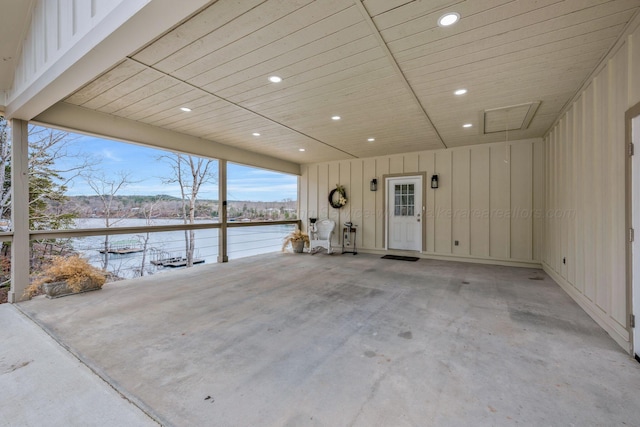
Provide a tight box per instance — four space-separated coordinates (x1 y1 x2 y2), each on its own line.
11 253 640 427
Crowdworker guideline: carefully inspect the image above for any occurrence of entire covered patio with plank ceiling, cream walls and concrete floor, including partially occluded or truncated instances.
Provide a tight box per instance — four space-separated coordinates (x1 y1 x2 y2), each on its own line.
0 0 640 427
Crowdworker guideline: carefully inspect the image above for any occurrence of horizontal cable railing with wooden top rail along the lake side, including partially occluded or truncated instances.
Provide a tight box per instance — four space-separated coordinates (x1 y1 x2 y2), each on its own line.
25 220 300 279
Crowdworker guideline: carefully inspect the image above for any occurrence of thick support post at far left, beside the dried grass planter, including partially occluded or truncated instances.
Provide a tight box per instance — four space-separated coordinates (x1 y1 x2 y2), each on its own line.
8 119 29 303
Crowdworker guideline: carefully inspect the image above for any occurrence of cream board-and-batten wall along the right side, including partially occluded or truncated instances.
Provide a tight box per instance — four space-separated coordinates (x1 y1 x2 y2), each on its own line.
542 20 640 350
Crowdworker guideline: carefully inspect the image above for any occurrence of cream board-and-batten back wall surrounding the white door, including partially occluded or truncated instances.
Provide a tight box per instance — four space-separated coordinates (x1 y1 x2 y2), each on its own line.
300 139 545 266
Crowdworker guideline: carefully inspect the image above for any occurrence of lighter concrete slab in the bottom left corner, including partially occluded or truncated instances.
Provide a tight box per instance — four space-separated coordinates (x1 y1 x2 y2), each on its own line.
0 304 158 427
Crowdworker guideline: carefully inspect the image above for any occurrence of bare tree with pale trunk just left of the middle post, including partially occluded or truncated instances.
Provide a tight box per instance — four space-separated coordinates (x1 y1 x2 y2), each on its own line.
161 154 217 267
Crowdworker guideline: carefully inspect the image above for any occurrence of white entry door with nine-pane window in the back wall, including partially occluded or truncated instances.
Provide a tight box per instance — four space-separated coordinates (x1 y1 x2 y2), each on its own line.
386 176 422 251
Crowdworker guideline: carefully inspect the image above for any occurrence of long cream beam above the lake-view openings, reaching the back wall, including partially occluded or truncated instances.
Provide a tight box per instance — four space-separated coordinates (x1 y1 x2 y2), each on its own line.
32 102 300 176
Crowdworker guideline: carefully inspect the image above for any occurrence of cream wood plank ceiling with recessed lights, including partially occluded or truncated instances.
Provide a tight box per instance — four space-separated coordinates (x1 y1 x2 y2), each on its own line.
65 0 640 163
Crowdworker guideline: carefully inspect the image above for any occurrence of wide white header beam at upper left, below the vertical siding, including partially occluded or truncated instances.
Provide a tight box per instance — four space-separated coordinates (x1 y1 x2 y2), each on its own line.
6 0 210 120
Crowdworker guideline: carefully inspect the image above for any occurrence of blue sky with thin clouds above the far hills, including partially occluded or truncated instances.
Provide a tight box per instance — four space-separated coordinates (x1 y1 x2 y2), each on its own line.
61 135 297 202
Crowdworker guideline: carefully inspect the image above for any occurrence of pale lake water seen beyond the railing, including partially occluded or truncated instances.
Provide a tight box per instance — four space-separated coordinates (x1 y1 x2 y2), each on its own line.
71 218 295 278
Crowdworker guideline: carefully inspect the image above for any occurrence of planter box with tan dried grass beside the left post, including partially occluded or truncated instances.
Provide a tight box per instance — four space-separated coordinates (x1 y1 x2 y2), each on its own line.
26 255 107 298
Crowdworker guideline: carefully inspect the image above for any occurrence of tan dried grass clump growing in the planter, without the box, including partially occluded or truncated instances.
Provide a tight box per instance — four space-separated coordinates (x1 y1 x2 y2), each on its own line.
26 255 107 297
